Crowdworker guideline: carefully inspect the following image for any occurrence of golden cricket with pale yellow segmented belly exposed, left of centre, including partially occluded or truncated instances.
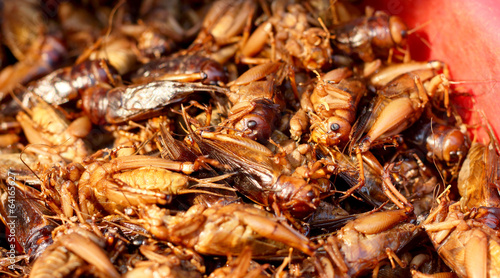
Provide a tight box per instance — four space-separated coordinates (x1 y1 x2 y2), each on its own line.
78 155 230 215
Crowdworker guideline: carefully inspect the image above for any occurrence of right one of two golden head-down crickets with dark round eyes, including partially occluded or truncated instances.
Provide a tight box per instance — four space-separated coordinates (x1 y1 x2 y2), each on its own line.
311 68 366 146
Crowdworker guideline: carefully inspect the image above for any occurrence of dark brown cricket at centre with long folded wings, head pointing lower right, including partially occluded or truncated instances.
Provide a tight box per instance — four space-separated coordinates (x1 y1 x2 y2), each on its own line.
185 116 320 218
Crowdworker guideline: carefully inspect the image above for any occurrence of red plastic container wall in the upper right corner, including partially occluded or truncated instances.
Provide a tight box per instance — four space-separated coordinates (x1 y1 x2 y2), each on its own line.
363 0 500 139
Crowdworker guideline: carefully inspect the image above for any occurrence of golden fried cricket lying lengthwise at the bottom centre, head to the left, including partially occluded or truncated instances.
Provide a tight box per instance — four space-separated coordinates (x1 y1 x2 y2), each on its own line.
141 203 315 257
